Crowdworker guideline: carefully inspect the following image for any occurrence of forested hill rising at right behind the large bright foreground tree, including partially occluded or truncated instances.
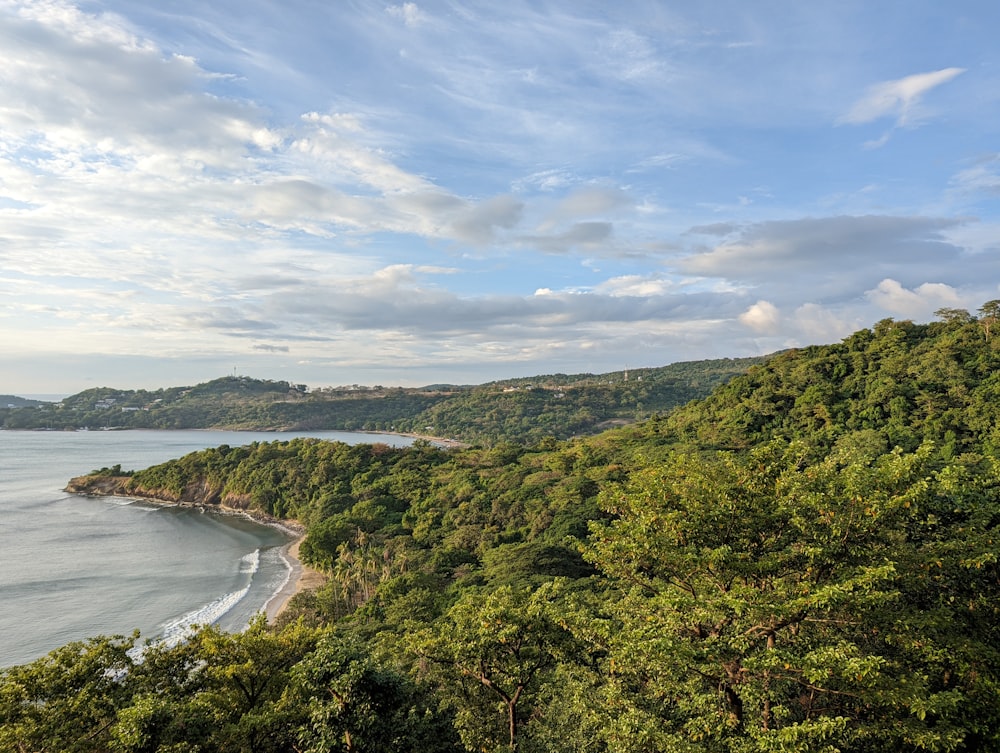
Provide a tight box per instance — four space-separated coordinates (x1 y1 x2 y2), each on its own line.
620 318 1000 458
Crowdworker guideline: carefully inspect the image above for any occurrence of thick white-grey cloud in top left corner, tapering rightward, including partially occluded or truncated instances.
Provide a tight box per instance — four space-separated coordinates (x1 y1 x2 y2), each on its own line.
0 2 280 172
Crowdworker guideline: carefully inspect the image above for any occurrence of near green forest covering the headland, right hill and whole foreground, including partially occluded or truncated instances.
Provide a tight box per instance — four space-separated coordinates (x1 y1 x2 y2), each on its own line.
0 302 1000 753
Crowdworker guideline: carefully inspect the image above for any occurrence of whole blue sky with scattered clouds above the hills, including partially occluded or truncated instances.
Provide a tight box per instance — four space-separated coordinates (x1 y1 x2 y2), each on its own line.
0 0 1000 395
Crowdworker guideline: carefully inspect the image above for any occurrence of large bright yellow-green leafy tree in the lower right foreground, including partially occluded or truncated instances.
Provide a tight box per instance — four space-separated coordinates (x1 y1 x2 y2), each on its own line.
588 434 1000 753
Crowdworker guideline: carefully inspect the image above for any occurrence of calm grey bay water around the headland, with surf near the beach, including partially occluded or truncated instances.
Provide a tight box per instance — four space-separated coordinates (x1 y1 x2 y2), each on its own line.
0 431 411 667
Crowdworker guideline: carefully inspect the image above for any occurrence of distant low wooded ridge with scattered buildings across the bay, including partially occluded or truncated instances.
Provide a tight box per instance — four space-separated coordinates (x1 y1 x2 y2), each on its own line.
0 358 763 444
